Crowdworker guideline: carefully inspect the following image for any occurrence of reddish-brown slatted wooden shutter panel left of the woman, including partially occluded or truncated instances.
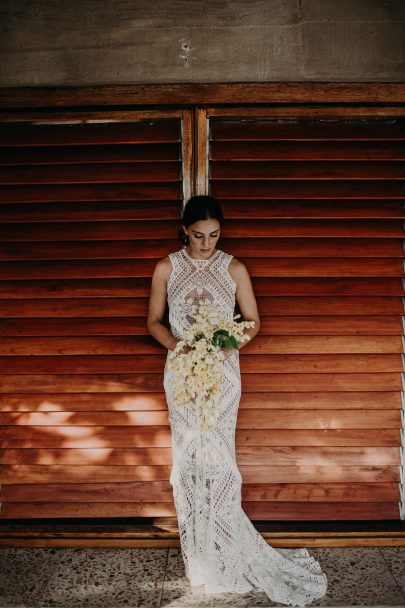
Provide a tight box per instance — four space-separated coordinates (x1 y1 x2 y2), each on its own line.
0 116 191 519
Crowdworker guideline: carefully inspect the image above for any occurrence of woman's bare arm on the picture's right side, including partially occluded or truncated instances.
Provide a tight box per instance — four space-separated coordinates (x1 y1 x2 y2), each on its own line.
228 258 260 350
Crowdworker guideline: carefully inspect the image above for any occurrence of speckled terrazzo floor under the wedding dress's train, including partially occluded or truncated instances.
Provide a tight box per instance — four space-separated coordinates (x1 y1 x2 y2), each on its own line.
0 547 405 608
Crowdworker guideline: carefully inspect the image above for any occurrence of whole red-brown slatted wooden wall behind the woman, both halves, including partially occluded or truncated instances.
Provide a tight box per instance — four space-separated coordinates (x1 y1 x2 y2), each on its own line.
0 110 405 521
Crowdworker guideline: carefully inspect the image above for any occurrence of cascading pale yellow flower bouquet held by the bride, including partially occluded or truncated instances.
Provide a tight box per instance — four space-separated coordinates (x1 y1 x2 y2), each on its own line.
168 299 255 429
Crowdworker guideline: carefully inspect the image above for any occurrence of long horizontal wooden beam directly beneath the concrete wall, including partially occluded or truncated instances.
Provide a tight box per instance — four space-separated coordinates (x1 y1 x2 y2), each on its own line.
0 82 405 109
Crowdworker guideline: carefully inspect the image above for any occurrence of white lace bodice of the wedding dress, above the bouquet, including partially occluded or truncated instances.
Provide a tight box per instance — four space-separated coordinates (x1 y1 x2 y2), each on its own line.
167 249 236 339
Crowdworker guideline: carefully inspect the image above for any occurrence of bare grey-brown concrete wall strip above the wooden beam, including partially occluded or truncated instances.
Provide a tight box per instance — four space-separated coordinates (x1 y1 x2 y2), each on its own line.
0 0 405 86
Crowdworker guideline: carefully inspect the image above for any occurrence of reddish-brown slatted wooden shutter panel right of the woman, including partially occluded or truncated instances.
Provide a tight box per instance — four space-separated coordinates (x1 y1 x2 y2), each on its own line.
208 116 405 520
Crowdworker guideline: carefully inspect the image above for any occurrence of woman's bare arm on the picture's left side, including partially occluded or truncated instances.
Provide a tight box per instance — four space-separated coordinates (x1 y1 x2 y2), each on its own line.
147 257 179 350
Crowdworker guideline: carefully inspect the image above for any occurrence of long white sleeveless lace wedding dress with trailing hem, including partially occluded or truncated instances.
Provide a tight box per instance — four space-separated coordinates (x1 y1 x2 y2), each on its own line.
164 249 327 606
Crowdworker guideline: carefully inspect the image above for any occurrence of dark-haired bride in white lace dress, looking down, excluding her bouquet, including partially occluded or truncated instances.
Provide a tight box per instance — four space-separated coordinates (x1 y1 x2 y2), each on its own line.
148 196 327 606
